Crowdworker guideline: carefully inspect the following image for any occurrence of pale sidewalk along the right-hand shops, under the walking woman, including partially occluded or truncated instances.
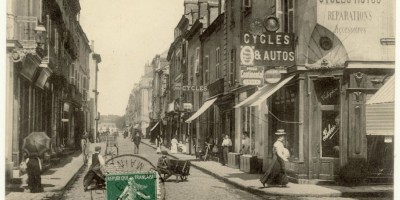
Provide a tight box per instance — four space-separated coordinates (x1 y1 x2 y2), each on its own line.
142 139 393 197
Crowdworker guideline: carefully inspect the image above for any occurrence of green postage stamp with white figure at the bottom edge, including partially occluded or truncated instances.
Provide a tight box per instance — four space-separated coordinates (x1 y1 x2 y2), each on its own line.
106 171 160 200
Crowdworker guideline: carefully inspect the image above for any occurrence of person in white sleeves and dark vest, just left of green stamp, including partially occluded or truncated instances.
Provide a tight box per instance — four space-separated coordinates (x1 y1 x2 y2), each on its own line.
83 146 106 191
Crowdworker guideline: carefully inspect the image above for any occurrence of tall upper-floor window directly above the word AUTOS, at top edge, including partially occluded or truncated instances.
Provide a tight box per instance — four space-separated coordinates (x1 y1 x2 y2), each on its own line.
276 0 294 33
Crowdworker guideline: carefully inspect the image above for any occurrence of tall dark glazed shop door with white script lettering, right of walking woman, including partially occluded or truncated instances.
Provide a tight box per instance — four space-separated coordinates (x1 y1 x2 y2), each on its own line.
311 78 341 180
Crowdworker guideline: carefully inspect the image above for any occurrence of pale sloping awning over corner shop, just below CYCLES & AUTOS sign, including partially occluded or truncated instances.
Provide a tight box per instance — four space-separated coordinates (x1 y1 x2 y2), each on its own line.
234 75 295 108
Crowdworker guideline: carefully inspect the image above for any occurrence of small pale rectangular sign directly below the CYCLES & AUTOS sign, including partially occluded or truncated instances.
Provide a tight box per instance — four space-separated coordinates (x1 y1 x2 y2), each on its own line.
240 66 264 85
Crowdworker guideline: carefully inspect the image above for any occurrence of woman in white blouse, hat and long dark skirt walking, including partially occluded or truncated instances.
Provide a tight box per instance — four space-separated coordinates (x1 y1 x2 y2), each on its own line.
260 129 289 187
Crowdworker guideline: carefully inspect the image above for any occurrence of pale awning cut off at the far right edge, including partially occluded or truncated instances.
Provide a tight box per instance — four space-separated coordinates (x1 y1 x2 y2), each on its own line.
365 75 395 136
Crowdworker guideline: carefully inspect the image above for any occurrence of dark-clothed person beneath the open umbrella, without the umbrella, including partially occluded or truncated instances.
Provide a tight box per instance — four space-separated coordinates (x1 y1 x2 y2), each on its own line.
25 152 43 193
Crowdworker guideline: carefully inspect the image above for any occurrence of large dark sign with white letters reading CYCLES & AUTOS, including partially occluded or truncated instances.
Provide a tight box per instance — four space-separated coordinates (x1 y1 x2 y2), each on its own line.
240 32 295 67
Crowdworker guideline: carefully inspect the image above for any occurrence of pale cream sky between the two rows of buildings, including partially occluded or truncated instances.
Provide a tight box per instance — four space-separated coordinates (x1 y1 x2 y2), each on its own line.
80 0 184 115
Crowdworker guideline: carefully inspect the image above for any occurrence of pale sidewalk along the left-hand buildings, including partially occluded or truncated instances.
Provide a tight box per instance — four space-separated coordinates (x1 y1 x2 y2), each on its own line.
6 143 105 200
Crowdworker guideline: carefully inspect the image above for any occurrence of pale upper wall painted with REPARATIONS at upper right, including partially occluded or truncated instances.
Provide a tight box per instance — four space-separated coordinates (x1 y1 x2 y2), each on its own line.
317 0 396 60
